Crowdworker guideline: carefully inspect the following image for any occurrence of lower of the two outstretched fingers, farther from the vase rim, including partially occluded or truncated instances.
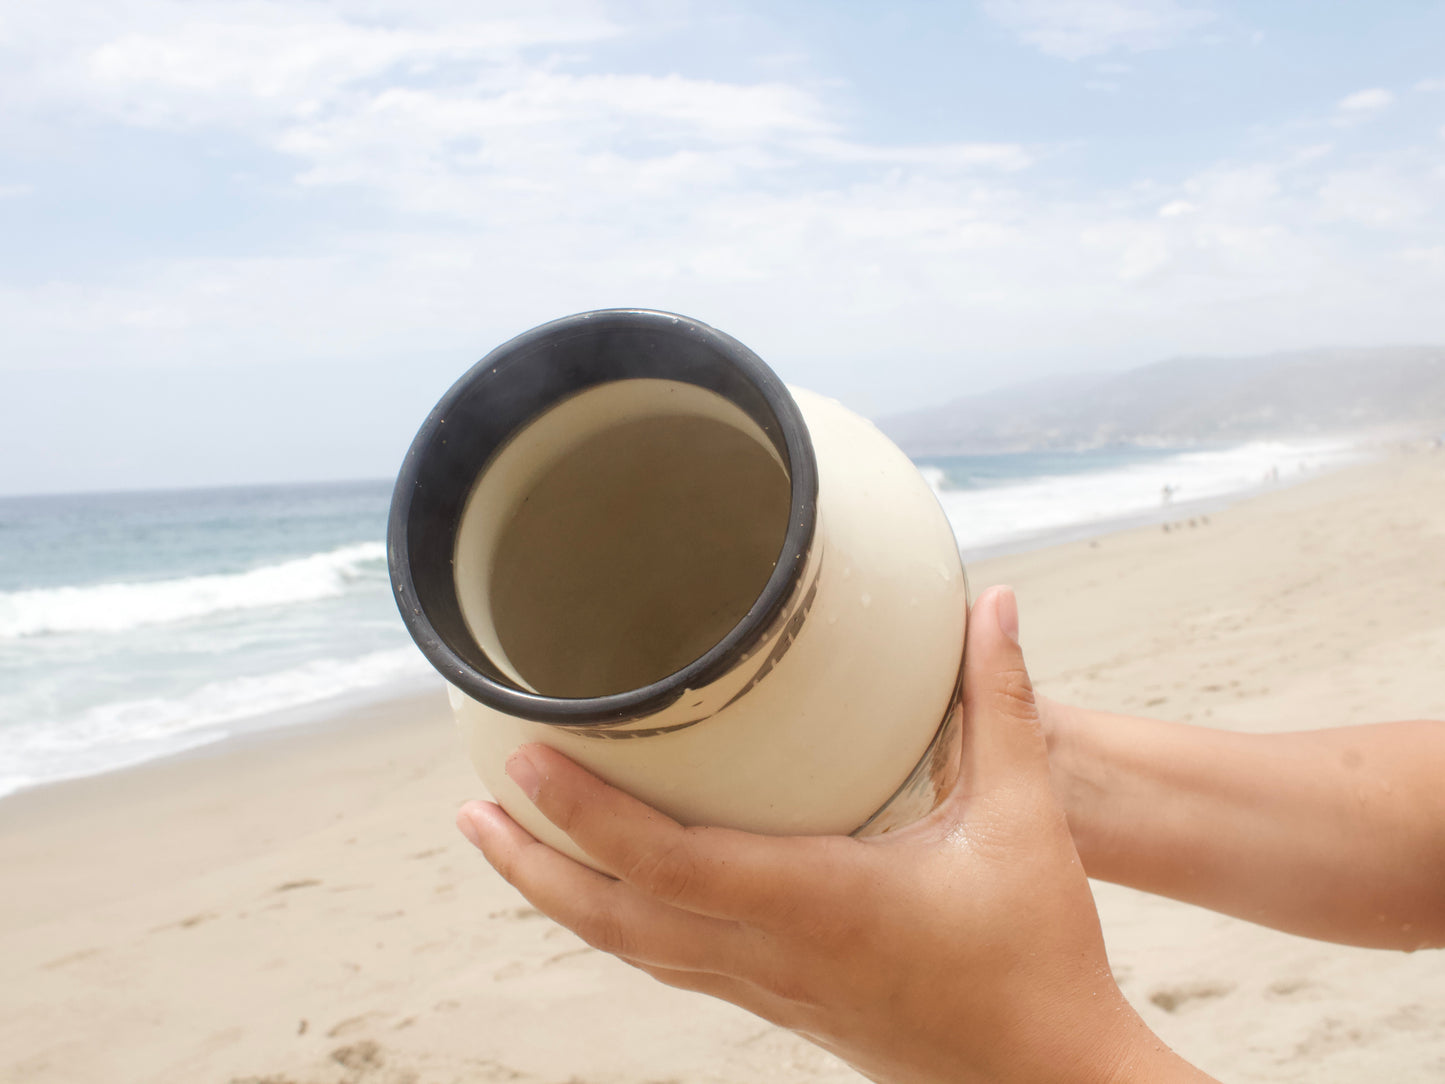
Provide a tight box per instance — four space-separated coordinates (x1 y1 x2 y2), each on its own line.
457 802 756 971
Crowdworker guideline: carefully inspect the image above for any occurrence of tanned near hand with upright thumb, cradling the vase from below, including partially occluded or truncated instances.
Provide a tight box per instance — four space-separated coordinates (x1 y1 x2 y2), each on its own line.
458 588 1202 1084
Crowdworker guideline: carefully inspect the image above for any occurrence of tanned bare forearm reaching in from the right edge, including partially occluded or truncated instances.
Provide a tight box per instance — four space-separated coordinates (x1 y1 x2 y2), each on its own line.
1045 702 1445 948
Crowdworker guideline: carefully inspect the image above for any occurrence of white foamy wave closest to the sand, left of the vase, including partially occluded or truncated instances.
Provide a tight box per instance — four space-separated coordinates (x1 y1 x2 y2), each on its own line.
0 648 435 795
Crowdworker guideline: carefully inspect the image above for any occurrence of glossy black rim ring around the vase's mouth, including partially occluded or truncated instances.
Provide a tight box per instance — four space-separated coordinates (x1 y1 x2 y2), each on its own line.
387 309 818 727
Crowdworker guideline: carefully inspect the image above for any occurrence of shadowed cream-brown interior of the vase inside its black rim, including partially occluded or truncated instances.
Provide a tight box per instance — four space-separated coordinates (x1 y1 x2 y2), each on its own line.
454 380 789 698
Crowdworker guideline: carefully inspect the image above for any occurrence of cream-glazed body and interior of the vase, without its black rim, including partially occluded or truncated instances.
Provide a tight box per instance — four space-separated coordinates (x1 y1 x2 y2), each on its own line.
451 390 967 861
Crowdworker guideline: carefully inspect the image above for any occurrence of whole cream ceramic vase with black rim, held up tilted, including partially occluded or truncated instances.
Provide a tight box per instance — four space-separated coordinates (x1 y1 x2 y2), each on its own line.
389 309 967 861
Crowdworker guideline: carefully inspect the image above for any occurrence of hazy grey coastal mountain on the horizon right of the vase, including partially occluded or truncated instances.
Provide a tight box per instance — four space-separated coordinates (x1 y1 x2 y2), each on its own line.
877 347 1445 455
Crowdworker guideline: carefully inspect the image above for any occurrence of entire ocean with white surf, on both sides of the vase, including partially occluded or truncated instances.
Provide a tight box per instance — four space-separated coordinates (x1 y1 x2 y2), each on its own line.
0 442 1358 795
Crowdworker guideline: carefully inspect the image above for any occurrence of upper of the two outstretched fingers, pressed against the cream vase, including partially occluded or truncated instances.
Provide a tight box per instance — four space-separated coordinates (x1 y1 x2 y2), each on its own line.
507 746 805 921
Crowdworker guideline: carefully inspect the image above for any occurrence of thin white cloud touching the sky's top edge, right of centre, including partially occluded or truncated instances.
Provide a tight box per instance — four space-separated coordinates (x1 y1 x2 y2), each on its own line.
984 0 1215 61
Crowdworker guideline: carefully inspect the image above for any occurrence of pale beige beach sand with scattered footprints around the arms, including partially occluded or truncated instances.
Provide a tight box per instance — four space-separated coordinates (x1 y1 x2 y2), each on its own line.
0 451 1445 1084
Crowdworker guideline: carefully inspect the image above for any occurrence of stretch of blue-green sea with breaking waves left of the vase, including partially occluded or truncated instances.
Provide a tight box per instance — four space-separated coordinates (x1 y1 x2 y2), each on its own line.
0 481 436 793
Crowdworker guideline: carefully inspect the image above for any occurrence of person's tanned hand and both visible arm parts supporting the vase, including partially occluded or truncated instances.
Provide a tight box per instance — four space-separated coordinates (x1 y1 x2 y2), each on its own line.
458 588 1445 1084
